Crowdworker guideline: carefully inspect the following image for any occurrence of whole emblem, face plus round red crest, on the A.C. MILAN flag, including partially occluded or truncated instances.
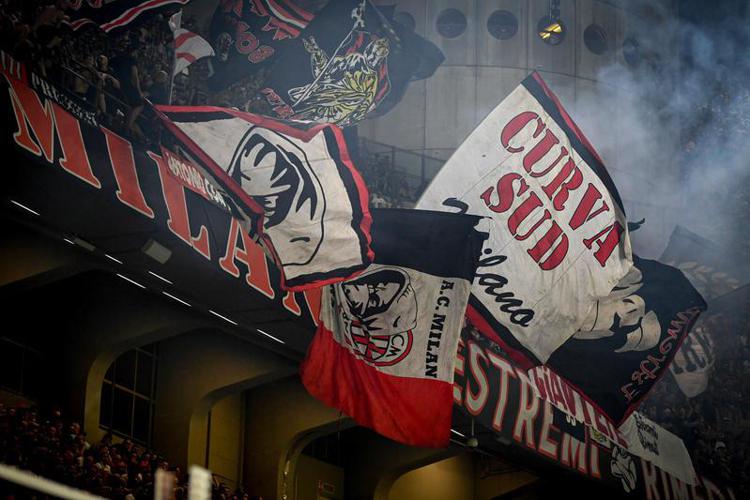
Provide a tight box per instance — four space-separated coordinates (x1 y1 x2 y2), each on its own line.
336 267 417 366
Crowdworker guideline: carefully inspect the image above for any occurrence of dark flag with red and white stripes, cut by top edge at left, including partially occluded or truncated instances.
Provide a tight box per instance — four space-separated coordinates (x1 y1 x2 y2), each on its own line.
64 0 190 33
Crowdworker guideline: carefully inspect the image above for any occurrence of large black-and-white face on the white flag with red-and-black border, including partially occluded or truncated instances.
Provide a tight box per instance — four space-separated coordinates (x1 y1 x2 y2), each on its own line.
228 127 325 266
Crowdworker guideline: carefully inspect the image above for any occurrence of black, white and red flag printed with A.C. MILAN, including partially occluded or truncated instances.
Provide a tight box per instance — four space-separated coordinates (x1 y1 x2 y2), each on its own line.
301 209 481 447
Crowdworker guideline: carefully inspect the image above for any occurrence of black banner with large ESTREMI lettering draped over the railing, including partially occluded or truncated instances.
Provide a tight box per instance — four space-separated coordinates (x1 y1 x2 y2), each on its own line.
453 328 735 500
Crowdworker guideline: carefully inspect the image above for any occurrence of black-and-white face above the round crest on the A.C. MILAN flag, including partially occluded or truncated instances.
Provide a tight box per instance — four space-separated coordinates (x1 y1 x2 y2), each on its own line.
340 268 417 336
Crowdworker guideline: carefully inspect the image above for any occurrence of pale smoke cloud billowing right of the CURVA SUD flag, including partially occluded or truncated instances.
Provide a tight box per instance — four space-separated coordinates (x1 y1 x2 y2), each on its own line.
572 4 750 258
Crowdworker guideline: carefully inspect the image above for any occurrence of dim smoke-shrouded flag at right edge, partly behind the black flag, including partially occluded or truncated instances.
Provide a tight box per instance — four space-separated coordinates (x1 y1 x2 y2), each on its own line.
659 226 750 398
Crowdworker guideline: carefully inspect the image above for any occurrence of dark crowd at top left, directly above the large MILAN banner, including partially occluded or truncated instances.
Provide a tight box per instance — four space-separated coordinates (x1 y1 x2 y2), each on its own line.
0 0 181 140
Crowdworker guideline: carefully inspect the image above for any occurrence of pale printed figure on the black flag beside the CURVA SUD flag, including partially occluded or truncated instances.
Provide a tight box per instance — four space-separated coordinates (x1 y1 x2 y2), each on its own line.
573 267 661 353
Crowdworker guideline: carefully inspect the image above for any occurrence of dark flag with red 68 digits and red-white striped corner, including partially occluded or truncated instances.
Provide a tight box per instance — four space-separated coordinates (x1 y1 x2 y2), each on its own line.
209 0 315 90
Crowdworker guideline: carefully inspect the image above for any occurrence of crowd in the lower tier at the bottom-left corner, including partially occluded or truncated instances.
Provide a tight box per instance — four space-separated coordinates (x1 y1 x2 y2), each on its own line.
0 404 249 500
